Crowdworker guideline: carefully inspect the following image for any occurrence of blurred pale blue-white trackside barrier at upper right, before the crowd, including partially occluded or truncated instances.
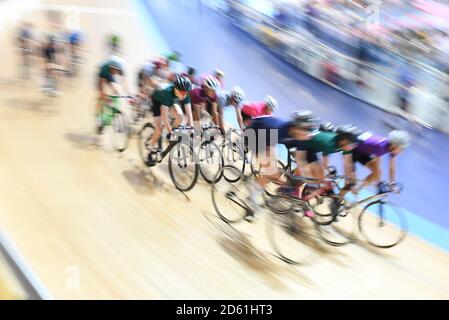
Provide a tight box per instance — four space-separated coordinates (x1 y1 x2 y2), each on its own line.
205 0 449 133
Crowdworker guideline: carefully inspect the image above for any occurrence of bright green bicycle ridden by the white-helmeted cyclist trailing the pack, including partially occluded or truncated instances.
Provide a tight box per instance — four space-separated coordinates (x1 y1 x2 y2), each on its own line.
97 95 132 152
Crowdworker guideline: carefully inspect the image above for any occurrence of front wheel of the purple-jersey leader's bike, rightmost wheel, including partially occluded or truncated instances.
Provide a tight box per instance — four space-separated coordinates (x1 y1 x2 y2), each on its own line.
358 200 408 249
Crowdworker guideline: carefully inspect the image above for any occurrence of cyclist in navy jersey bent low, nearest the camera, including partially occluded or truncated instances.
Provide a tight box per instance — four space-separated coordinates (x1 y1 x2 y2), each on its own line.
245 111 316 220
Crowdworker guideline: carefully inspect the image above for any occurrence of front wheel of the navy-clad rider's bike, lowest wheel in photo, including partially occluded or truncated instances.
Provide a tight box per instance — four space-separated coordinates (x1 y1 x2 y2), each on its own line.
267 209 317 265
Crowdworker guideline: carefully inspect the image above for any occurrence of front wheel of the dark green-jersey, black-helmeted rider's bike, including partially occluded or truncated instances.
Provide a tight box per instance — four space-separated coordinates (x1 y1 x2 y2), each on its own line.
168 142 198 191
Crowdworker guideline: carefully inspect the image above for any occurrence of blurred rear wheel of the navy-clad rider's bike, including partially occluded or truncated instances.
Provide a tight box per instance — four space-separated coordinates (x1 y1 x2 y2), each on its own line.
211 166 252 223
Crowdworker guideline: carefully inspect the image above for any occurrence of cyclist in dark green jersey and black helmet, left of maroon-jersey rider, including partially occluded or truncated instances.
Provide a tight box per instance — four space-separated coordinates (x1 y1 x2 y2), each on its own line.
147 74 193 165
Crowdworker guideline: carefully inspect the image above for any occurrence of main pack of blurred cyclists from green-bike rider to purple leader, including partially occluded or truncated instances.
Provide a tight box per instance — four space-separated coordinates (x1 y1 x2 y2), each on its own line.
90 35 410 220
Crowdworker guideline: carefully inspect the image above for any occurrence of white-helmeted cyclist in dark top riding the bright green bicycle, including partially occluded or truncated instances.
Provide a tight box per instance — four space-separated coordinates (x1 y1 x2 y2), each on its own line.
95 55 129 134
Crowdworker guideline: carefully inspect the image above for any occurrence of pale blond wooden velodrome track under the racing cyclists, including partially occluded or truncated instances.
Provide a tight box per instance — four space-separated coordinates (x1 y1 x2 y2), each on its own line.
0 0 449 299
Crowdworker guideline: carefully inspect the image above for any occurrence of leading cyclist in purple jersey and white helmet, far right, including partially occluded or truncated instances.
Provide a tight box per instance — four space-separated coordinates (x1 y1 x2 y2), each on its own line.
345 130 410 191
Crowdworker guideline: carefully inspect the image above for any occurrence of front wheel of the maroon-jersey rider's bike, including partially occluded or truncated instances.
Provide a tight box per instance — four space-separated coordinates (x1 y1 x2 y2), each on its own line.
197 141 224 183
